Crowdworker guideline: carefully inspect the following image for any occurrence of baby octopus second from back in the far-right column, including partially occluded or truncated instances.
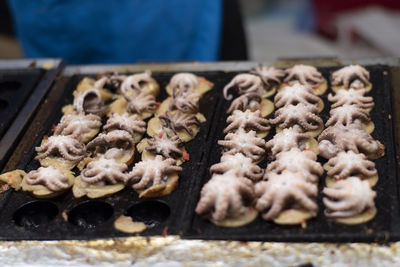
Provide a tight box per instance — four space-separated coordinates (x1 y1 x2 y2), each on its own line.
328 89 375 109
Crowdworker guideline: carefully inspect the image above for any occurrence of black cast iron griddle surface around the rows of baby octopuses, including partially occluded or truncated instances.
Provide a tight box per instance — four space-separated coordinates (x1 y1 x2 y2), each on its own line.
0 65 400 242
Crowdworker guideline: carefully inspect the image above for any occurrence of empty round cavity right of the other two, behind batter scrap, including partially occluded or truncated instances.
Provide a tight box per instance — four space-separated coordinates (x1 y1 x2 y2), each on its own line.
126 200 171 228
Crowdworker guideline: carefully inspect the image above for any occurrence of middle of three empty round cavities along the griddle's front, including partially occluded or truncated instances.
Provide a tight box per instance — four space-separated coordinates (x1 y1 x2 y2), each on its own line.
68 200 114 229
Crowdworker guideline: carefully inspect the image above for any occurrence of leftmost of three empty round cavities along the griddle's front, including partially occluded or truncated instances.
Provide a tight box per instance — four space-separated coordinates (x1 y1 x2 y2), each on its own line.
13 200 58 229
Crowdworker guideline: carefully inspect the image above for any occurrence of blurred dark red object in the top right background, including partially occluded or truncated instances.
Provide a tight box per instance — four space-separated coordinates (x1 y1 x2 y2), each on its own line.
313 0 400 38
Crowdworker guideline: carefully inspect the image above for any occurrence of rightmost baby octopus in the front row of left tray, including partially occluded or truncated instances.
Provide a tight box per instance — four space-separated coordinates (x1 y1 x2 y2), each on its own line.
129 155 182 190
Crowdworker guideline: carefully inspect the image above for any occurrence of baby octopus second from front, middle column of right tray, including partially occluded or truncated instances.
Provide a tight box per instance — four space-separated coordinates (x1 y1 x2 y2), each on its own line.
264 148 324 183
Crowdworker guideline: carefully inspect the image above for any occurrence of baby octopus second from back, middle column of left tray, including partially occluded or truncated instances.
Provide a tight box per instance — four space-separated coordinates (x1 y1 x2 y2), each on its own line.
124 90 157 114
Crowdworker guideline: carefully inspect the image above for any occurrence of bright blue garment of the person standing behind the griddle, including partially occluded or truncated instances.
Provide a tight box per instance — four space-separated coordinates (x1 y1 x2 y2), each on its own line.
8 0 222 64
